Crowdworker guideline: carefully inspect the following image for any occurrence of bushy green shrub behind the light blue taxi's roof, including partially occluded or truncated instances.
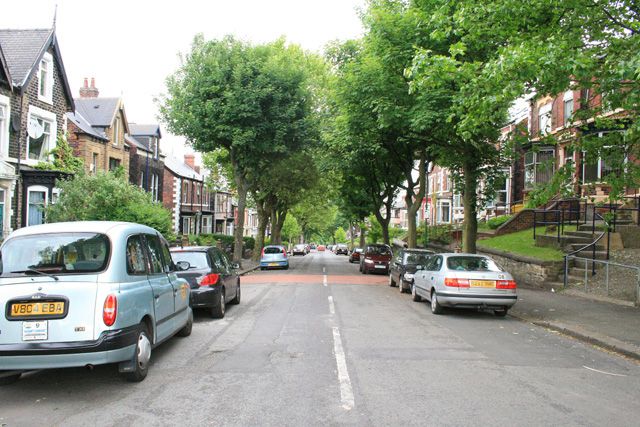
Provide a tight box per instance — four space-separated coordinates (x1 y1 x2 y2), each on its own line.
45 172 174 239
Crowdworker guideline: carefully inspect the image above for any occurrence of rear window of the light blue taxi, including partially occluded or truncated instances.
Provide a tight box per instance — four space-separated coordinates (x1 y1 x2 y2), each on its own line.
0 233 110 277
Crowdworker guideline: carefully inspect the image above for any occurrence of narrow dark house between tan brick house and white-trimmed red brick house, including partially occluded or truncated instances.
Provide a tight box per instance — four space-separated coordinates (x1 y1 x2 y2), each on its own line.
127 123 165 202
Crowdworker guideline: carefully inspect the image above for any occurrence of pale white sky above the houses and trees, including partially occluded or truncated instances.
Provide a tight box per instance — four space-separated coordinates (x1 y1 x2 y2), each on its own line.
0 0 366 162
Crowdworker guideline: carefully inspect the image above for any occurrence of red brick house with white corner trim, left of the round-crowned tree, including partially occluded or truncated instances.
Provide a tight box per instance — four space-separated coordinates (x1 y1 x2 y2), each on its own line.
162 154 215 234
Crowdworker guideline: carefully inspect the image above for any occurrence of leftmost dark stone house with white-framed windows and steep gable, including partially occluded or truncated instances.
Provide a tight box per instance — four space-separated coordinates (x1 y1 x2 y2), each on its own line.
0 29 74 237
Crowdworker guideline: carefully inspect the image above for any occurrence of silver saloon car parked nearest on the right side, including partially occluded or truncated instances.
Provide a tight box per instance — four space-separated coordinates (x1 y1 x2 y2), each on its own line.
411 253 518 317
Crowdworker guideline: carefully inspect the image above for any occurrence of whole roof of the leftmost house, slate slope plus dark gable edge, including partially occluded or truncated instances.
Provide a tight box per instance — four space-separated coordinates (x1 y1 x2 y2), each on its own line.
0 28 74 109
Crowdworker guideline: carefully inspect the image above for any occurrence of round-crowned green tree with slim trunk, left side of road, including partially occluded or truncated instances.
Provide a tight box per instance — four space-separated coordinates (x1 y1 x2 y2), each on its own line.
160 35 316 261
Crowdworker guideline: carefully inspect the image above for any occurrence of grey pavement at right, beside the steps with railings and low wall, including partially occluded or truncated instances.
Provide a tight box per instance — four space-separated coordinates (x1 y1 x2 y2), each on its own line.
509 288 640 360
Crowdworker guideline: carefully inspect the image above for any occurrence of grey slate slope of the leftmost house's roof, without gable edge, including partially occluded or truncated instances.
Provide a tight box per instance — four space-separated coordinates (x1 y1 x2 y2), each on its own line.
0 29 53 87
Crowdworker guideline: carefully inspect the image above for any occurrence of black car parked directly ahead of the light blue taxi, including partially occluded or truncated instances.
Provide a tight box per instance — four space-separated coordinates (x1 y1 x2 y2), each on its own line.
171 246 240 319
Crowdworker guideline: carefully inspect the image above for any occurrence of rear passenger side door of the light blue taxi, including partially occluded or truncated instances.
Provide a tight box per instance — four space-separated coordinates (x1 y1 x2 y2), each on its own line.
145 234 175 342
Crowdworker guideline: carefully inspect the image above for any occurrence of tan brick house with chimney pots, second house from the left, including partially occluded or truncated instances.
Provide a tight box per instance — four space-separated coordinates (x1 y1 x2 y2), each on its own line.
67 78 129 174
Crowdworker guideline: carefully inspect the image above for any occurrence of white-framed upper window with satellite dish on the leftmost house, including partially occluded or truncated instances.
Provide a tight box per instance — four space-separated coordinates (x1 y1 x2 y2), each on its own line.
27 106 57 163
